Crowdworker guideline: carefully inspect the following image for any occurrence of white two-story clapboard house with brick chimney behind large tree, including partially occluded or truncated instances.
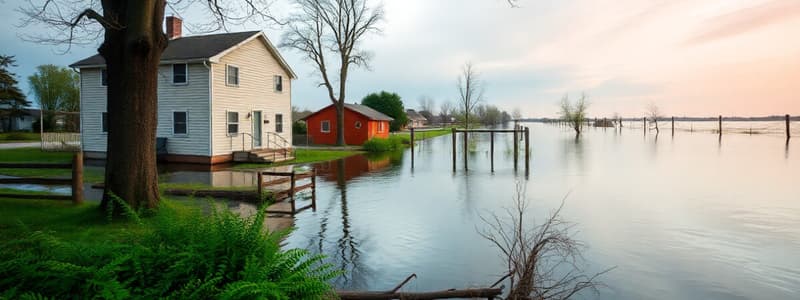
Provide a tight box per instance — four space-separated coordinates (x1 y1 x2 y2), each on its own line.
71 17 297 164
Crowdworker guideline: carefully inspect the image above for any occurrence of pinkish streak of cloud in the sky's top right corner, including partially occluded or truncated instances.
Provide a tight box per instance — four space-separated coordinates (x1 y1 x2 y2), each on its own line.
686 0 800 45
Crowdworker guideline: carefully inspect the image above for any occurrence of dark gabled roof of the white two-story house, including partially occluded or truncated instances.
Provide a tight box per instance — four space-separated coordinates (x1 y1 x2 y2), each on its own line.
70 31 297 78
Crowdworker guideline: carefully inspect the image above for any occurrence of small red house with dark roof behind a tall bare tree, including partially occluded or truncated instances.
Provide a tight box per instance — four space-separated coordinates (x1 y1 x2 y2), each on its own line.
303 104 394 145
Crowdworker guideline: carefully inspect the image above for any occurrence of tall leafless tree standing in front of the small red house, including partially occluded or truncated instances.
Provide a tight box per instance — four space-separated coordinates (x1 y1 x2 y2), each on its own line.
281 0 383 145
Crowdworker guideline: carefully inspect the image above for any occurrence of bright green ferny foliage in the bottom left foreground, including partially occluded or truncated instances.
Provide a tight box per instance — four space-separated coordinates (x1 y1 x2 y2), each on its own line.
0 198 339 299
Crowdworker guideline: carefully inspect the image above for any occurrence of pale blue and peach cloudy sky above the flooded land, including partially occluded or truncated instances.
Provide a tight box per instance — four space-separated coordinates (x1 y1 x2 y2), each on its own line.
0 0 800 117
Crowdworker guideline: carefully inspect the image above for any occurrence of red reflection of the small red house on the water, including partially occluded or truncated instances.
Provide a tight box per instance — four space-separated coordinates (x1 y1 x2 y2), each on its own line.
314 155 392 181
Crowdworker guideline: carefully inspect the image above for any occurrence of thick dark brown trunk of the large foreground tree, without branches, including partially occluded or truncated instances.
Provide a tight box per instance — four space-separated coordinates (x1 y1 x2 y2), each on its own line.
99 0 167 209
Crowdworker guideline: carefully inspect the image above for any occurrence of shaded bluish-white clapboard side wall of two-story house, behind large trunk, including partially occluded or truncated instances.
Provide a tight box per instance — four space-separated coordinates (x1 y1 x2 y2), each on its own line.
81 63 210 156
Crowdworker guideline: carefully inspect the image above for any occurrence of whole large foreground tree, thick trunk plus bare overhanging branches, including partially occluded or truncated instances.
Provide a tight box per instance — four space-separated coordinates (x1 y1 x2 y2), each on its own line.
20 0 284 209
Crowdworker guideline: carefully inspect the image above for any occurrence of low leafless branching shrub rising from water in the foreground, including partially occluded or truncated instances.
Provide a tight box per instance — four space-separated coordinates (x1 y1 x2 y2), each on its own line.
479 182 611 299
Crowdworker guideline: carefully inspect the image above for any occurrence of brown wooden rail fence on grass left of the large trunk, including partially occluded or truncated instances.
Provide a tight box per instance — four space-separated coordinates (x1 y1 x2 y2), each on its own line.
0 152 83 204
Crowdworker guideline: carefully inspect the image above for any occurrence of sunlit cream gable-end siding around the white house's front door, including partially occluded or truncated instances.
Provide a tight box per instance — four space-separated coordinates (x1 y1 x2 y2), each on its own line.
211 39 292 155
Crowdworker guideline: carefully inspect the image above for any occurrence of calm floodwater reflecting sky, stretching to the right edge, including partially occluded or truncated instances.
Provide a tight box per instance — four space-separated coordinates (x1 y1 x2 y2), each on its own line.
280 124 800 299
